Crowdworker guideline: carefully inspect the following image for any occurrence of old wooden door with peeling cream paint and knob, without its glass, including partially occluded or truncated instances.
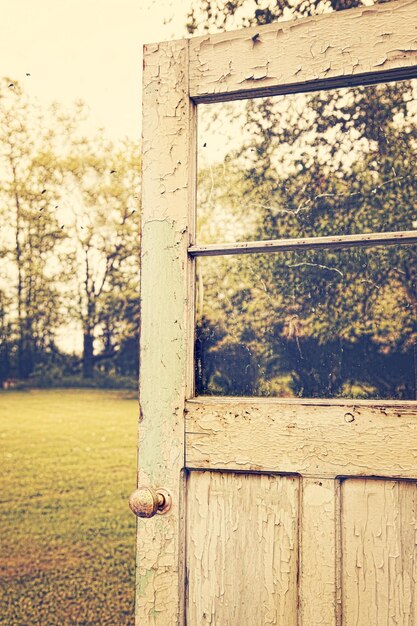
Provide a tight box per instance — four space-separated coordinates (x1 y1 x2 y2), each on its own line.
133 0 417 626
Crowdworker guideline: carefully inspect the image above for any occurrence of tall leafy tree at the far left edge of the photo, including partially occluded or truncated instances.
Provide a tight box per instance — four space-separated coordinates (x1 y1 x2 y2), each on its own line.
0 78 65 379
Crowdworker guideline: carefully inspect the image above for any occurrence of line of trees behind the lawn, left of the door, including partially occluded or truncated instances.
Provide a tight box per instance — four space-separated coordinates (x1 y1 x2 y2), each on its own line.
0 78 140 386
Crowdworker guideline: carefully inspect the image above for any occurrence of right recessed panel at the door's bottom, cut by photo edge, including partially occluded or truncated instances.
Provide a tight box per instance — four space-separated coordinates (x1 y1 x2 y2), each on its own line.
342 480 417 626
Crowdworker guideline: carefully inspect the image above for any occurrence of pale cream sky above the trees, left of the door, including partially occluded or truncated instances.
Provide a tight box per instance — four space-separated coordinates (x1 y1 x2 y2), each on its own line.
0 0 190 139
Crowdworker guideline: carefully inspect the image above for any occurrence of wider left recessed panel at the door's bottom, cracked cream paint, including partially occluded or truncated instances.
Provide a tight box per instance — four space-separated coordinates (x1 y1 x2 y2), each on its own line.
187 472 299 626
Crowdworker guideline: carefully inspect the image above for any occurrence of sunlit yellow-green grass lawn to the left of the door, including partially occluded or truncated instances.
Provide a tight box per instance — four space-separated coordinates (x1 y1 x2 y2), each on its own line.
0 390 138 626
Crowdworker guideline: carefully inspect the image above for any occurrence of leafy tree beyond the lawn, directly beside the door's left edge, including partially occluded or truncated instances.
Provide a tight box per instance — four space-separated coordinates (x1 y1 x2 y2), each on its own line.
61 137 140 378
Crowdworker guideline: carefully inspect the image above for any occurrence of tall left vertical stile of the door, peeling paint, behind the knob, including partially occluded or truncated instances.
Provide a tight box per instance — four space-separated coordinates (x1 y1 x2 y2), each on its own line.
136 41 195 626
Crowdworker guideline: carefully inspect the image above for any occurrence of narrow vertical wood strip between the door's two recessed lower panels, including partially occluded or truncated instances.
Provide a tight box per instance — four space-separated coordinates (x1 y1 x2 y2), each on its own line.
299 478 337 626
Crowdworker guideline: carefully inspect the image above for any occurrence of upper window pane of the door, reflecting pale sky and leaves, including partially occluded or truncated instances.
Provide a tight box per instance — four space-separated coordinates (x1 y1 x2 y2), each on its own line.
197 79 417 244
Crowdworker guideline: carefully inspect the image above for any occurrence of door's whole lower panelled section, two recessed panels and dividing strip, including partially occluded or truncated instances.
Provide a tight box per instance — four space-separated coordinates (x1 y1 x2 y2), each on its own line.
186 471 417 626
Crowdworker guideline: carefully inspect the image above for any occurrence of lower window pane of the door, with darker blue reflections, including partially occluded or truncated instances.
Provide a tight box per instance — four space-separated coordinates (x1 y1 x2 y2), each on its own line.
195 245 417 400
